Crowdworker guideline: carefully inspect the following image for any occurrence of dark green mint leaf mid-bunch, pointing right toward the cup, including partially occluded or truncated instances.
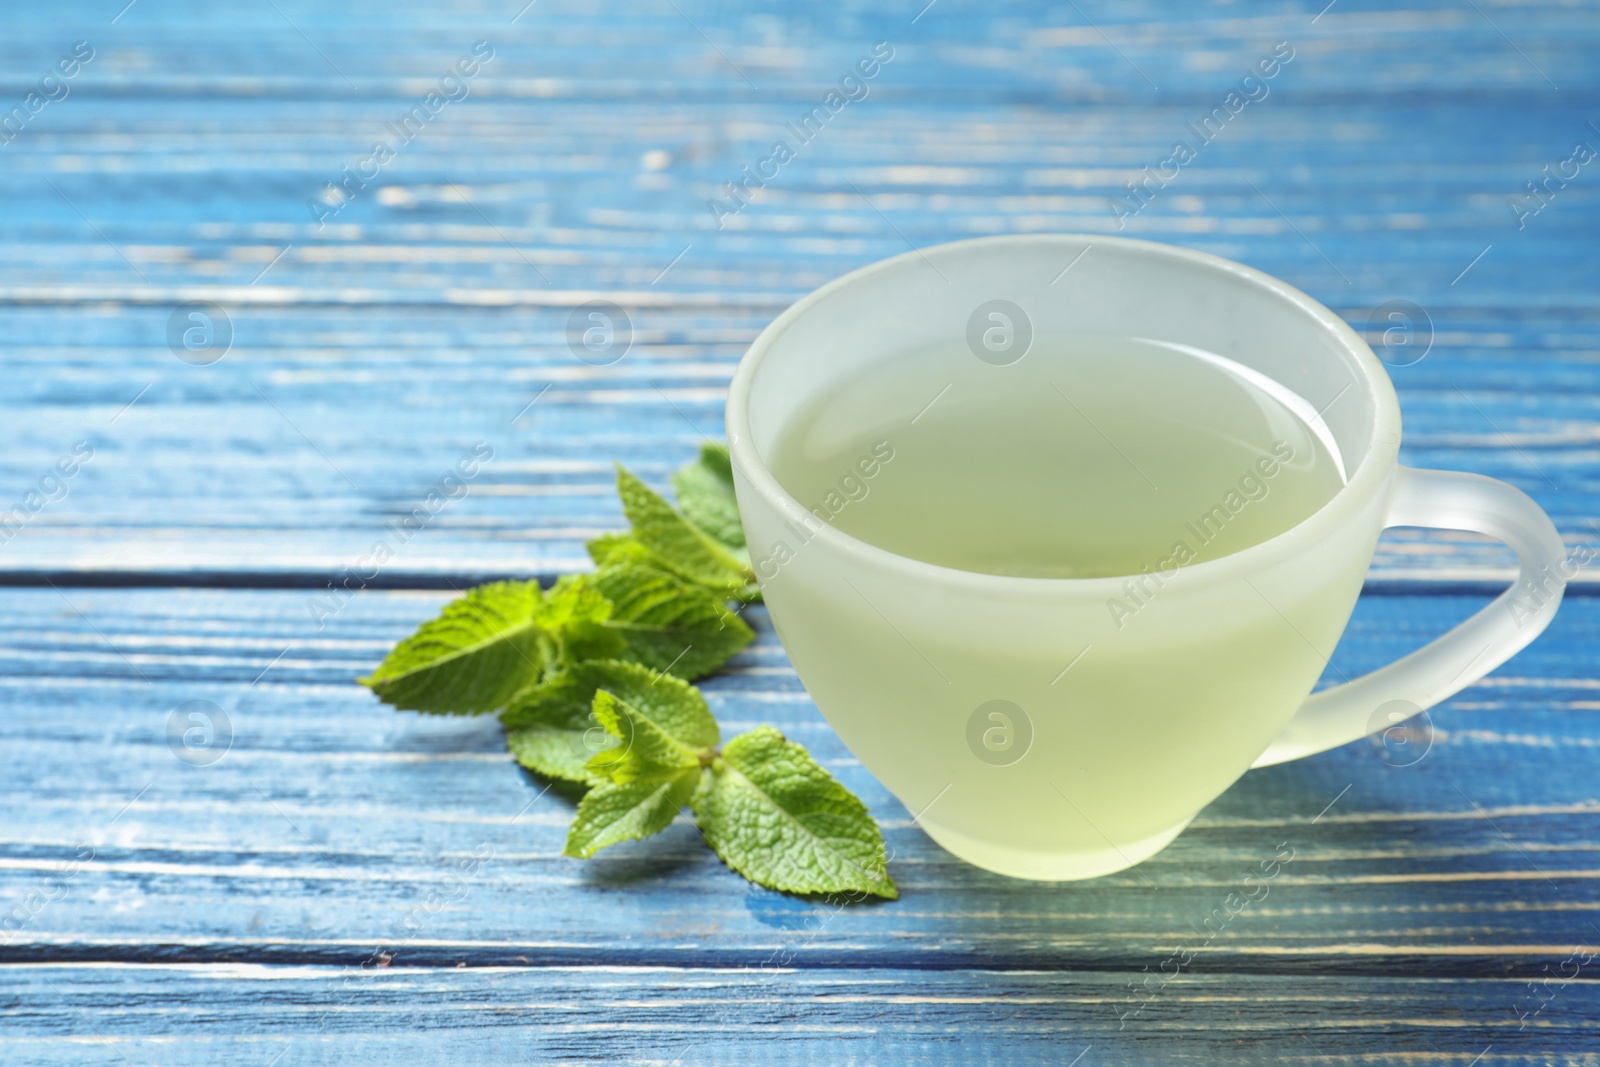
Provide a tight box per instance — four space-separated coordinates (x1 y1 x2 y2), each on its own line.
594 563 755 680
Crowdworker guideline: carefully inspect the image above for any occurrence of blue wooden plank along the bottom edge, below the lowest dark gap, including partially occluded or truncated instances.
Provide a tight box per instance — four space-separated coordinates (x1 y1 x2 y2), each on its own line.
0 966 1600 1067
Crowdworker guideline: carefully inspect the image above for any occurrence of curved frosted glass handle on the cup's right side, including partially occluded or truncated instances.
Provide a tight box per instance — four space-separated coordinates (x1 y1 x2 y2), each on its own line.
1251 467 1566 766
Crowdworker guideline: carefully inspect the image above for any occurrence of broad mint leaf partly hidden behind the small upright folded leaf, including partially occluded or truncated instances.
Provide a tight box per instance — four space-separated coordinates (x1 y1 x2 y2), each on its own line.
501 661 722 784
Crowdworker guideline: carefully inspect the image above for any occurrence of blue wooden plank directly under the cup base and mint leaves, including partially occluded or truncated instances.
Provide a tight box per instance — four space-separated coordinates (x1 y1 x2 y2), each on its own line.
0 589 1600 977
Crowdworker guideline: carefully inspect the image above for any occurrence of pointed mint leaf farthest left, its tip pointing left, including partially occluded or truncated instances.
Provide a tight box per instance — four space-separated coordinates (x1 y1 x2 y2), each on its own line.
360 582 542 715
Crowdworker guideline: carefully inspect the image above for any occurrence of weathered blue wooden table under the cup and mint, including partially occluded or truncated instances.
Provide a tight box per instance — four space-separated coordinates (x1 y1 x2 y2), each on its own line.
0 0 1600 1067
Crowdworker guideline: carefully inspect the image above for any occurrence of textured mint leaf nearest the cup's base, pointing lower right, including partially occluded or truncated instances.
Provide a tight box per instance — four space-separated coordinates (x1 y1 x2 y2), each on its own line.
693 726 899 901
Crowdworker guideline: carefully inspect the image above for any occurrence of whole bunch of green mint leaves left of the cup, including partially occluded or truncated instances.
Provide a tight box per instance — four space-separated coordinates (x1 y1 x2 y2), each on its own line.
362 445 899 899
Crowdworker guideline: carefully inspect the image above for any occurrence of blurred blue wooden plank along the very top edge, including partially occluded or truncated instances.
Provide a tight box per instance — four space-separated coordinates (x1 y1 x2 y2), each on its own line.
3 0 1595 102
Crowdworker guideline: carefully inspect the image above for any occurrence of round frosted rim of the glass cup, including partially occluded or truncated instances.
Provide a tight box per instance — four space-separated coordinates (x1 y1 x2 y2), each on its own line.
726 234 1400 595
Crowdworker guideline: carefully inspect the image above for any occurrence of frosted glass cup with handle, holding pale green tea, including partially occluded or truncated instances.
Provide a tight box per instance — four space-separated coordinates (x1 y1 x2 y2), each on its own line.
728 235 1566 878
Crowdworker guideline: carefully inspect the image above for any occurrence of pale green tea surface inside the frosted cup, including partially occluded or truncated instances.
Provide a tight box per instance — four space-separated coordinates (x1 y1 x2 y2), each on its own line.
768 338 1346 577
